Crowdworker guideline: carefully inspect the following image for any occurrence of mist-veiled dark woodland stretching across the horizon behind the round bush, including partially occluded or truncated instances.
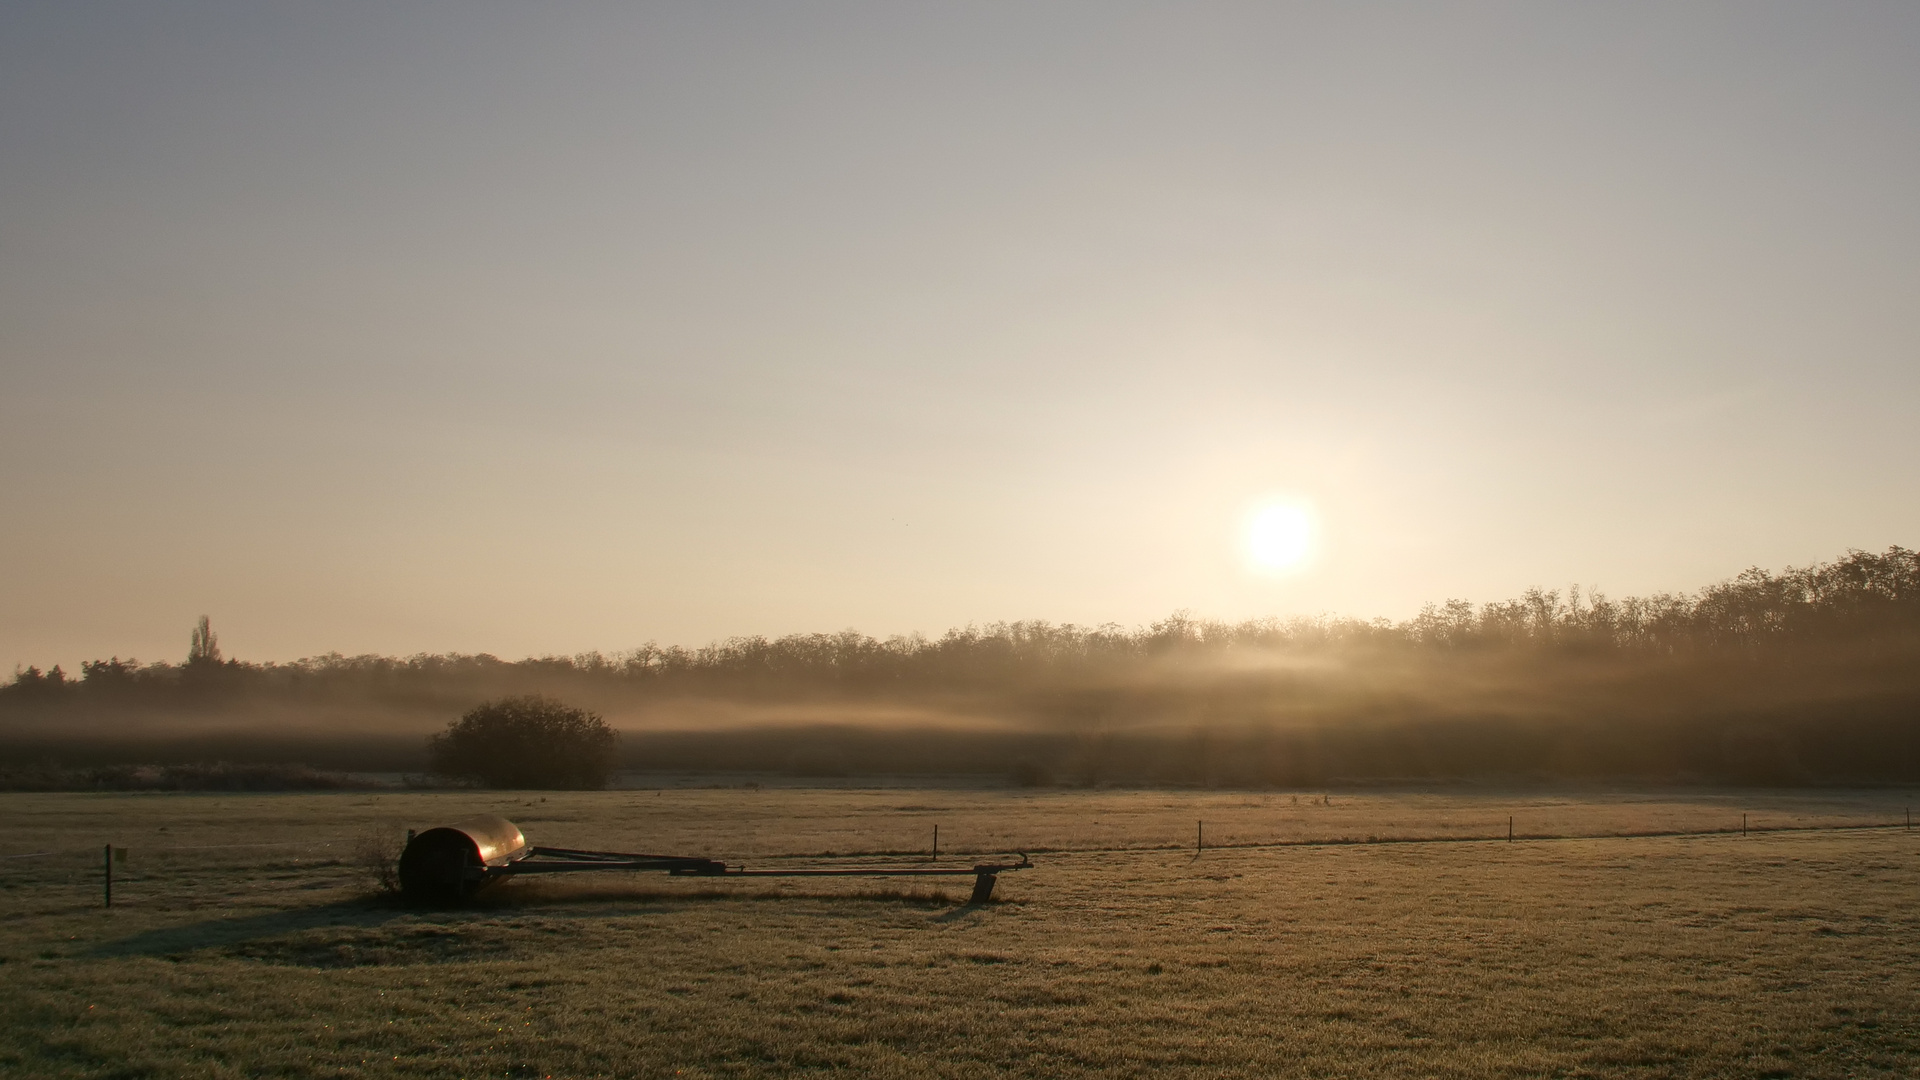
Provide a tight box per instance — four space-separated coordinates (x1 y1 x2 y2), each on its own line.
0 548 1920 786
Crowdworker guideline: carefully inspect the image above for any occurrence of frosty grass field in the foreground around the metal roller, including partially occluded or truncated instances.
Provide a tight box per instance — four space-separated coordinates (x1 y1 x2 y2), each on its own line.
0 788 1920 1076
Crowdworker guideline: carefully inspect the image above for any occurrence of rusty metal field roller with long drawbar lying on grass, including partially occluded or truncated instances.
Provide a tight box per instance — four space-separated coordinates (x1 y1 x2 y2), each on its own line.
399 815 1033 907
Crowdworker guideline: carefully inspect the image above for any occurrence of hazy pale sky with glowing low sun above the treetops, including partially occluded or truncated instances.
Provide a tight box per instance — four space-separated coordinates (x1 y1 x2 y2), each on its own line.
0 0 1920 671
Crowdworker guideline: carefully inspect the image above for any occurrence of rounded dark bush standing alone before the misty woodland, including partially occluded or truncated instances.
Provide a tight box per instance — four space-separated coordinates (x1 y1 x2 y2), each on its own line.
426 698 618 788
